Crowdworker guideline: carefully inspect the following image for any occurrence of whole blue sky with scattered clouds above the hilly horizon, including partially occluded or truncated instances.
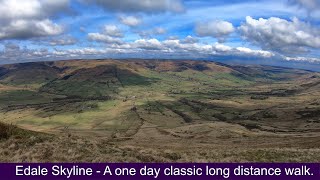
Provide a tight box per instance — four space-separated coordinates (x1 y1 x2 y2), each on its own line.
0 0 320 70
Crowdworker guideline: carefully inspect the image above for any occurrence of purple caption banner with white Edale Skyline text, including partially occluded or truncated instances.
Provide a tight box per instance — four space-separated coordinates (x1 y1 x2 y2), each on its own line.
0 163 320 179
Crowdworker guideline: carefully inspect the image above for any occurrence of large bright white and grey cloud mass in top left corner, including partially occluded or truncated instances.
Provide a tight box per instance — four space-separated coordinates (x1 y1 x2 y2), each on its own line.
0 0 69 40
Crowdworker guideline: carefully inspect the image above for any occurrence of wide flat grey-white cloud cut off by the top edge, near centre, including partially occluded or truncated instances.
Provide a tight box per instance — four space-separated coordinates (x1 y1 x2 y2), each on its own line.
82 0 184 13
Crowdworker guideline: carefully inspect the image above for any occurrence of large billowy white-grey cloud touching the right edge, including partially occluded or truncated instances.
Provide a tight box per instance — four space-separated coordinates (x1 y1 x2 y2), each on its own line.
239 16 320 53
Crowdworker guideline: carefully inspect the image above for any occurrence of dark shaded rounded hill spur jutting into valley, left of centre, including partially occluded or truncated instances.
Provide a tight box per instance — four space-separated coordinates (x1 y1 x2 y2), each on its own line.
40 65 158 98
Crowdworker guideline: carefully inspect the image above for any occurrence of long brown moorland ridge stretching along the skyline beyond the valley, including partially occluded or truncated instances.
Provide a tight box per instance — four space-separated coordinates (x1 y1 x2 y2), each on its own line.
0 60 310 94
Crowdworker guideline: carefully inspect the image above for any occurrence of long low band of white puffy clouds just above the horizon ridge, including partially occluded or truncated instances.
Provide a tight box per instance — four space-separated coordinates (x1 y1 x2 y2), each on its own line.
55 33 274 58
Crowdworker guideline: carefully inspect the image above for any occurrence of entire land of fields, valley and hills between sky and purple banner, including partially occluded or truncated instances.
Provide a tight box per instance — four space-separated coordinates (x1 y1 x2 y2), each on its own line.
0 60 320 162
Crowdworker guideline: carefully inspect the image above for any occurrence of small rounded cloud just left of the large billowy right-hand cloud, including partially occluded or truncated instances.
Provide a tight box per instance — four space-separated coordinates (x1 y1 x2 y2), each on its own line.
195 20 235 42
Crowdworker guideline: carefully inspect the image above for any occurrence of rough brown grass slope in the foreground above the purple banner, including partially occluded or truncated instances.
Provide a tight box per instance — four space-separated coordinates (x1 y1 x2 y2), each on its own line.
0 123 320 162
